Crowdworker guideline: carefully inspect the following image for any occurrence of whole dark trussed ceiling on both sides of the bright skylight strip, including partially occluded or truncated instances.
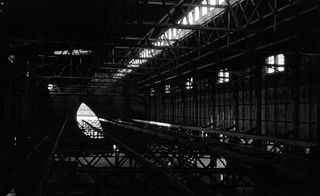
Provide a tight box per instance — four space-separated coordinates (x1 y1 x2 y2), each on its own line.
0 0 319 95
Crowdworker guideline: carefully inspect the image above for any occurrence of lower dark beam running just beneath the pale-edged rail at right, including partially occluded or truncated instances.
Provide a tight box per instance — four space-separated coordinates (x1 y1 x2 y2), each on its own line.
104 121 310 184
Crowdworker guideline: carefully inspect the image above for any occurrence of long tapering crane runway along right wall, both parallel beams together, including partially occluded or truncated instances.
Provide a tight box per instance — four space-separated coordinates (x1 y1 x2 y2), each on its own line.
100 119 316 185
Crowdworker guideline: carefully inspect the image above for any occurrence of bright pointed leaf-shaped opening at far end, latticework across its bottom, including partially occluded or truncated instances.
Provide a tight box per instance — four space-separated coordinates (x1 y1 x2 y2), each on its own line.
77 103 104 139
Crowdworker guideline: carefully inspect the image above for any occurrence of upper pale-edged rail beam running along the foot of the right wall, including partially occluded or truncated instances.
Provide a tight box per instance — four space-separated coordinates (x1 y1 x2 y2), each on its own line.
100 119 316 158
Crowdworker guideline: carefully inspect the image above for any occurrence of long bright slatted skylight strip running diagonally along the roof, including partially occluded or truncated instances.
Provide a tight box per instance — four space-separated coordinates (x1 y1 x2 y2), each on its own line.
113 0 229 79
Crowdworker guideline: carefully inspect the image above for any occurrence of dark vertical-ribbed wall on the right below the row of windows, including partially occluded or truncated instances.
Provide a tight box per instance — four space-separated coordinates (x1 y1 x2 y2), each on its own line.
149 55 320 141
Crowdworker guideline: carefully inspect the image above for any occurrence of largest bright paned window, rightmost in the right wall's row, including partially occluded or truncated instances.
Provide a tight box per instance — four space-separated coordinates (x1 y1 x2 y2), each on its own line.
265 54 285 74
